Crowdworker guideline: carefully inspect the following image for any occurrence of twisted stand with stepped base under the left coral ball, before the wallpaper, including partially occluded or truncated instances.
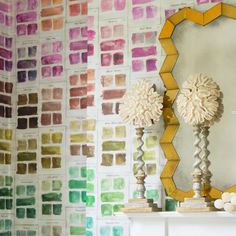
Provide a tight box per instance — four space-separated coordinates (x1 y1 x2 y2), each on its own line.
121 128 161 212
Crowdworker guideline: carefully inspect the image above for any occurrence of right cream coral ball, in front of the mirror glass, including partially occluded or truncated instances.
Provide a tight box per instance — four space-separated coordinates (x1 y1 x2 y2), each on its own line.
177 74 222 125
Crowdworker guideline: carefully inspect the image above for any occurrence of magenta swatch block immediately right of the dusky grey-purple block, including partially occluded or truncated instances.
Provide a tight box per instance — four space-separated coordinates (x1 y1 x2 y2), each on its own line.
41 38 64 80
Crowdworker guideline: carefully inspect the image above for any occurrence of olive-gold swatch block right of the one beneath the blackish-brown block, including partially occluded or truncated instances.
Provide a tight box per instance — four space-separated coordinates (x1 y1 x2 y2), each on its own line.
40 128 65 172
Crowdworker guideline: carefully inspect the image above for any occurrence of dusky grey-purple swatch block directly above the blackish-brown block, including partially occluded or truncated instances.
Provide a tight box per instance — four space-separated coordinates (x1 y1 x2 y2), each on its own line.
17 42 38 83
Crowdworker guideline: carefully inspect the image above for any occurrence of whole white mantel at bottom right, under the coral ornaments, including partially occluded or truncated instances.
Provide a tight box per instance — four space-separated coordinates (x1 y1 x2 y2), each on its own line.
119 211 236 236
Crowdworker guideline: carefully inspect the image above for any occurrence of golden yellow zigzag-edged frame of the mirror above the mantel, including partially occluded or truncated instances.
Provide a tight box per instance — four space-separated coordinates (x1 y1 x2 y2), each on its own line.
159 3 236 201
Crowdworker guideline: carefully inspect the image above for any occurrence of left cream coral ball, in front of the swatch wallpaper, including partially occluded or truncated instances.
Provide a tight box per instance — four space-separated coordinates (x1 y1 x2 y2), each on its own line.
119 80 163 127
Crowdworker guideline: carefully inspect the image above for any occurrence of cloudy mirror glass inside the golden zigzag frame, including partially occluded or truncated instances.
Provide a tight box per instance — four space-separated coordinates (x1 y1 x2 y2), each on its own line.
172 17 236 191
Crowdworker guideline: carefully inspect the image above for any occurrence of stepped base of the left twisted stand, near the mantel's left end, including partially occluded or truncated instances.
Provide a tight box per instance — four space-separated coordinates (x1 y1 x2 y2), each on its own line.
120 198 161 213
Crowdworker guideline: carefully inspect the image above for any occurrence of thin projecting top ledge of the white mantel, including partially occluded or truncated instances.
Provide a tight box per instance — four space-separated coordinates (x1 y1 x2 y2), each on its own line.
116 211 236 219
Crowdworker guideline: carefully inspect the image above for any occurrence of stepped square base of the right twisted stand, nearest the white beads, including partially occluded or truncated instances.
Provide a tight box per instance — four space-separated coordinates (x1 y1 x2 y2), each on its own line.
176 198 216 212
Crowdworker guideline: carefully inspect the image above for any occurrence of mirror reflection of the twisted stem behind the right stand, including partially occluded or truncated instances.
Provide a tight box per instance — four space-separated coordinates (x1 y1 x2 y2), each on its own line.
201 126 212 200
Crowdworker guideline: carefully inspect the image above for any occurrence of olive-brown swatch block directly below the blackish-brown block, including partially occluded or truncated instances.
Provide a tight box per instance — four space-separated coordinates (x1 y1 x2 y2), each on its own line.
16 133 38 175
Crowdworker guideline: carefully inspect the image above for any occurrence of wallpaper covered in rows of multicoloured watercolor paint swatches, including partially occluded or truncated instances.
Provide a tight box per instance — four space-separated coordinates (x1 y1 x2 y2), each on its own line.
0 0 225 236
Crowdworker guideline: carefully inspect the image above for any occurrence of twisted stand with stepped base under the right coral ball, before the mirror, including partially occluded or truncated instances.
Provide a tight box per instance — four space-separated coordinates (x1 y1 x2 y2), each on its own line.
176 125 215 212
